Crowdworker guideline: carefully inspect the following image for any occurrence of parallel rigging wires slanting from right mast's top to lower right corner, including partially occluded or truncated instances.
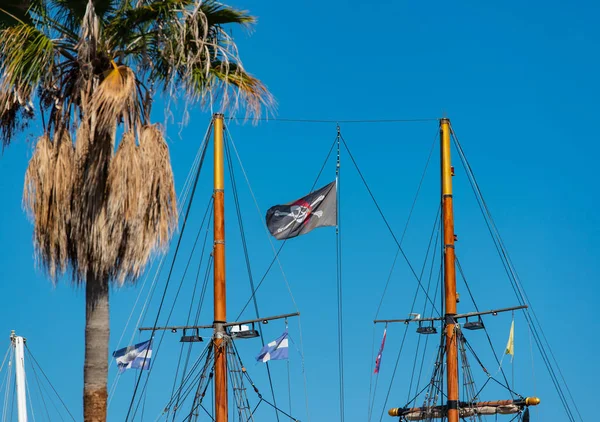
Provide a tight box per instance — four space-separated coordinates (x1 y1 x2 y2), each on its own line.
451 123 583 421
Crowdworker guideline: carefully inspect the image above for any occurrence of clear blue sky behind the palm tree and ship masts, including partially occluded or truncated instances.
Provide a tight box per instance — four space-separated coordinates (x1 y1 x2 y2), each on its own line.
0 0 600 422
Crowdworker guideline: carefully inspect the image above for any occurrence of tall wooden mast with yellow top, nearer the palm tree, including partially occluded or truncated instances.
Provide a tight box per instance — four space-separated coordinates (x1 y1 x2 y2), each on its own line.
213 114 228 422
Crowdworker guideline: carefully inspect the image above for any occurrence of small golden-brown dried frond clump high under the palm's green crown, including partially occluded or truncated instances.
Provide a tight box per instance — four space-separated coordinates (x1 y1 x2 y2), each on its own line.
88 62 140 133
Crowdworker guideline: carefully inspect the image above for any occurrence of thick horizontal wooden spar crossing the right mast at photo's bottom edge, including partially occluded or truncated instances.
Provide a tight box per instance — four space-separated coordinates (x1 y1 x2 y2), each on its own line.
388 397 540 421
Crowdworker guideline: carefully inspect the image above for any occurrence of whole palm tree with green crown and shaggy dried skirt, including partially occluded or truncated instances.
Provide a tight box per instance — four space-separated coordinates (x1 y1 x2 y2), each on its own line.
0 0 272 421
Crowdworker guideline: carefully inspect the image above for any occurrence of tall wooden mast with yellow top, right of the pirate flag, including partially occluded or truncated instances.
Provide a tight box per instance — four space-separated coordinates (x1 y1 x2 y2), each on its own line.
440 118 459 422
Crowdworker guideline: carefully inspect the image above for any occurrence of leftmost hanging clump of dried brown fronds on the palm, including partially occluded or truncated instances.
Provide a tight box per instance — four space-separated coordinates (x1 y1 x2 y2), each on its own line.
23 131 74 280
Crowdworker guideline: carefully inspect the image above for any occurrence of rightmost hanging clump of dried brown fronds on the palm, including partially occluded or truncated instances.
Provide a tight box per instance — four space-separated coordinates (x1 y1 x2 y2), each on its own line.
140 125 177 249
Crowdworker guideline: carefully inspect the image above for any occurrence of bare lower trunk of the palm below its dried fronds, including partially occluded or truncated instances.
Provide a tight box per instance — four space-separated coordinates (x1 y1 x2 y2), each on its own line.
83 271 110 422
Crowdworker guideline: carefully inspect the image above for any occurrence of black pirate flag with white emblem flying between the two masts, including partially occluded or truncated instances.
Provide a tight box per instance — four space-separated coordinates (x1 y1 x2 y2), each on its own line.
266 182 337 240
